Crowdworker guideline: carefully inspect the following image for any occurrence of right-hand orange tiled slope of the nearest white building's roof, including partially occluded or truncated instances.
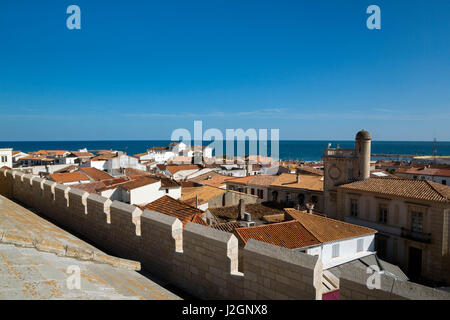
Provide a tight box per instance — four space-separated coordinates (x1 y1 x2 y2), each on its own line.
284 208 377 242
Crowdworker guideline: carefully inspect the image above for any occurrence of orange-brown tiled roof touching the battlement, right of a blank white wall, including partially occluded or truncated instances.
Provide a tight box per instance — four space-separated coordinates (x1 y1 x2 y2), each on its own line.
139 196 206 226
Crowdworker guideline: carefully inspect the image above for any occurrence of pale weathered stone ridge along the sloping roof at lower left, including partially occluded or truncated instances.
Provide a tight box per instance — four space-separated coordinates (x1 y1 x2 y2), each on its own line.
0 230 141 271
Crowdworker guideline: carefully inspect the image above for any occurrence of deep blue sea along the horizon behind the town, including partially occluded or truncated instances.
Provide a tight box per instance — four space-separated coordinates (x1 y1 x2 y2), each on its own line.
0 140 450 161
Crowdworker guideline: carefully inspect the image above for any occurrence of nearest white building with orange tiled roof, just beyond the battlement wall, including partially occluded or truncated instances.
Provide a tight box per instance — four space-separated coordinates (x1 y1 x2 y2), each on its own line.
235 209 377 270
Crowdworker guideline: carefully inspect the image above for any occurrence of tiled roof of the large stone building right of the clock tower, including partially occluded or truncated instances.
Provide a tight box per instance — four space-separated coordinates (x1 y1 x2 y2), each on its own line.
338 178 450 202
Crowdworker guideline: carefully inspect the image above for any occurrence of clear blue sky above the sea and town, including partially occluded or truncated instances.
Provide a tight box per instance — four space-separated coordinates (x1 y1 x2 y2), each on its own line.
0 0 450 141
